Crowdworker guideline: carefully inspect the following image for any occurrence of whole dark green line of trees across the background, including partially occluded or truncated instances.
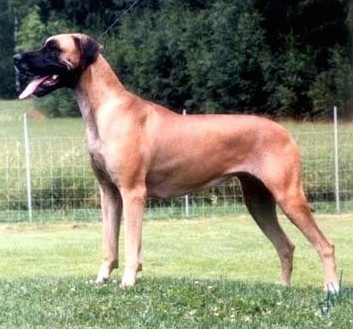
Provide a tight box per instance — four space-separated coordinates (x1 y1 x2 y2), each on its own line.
7 0 353 119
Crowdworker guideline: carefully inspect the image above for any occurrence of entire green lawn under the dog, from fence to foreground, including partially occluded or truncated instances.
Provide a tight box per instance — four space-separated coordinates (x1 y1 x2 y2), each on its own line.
0 215 353 328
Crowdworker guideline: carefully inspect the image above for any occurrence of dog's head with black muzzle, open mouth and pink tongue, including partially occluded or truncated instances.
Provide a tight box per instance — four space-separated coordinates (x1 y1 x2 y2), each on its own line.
14 33 101 99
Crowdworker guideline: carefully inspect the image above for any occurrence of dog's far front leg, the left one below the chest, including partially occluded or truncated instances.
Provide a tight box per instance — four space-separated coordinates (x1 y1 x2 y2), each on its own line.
96 184 122 283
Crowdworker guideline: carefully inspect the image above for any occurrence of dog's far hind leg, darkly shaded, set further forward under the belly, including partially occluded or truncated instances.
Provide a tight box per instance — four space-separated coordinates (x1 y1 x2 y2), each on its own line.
238 174 295 285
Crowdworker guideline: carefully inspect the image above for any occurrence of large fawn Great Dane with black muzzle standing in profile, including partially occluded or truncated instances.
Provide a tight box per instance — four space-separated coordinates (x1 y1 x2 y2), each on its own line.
14 33 339 292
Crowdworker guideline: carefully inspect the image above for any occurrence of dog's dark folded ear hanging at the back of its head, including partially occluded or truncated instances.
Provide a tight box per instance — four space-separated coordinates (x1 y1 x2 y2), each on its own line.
73 36 103 70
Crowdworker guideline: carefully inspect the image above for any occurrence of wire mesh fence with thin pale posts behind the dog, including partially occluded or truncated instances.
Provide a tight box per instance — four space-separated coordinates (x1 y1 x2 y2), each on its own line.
0 123 353 222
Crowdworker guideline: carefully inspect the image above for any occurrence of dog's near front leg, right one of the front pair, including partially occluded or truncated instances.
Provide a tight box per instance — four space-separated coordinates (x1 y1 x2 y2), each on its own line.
121 186 146 287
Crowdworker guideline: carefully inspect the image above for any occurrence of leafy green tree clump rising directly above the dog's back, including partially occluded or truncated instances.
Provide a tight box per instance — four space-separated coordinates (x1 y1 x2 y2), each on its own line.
106 0 267 112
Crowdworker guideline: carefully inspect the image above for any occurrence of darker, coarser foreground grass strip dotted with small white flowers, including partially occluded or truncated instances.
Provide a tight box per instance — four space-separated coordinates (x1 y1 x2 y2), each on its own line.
0 277 353 328
